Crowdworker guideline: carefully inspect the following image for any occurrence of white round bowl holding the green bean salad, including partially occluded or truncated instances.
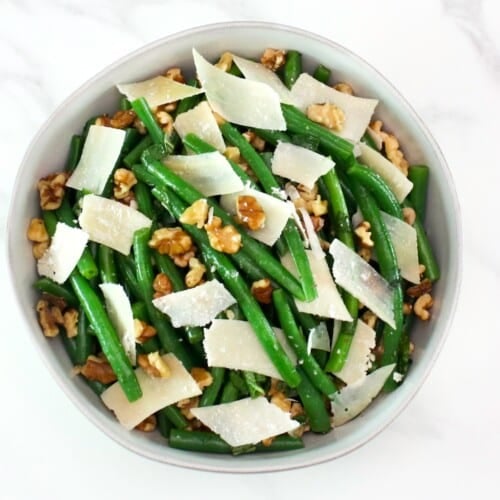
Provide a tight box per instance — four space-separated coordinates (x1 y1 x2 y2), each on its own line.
8 22 461 472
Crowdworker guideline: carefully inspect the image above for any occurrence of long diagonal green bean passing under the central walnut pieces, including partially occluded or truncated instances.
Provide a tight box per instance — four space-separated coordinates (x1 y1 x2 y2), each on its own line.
153 188 300 387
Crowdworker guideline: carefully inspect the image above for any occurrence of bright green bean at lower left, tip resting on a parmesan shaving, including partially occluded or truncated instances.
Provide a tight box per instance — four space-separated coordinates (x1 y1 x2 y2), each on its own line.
69 271 142 401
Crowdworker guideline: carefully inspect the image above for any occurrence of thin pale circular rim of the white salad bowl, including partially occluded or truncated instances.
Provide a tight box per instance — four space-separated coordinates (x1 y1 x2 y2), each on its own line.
4 21 463 473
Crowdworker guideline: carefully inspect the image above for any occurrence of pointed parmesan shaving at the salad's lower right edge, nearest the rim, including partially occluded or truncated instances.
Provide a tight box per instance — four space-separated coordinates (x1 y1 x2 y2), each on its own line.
331 364 396 427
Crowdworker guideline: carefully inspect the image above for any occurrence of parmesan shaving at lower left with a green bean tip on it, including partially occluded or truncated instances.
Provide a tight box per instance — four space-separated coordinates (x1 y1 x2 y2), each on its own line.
101 354 201 430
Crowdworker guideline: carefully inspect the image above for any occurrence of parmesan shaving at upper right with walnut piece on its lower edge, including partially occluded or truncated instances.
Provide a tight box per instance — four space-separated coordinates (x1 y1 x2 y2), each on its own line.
292 73 378 142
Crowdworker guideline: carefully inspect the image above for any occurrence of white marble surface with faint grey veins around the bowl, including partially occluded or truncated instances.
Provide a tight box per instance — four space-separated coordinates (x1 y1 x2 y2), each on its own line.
0 0 500 500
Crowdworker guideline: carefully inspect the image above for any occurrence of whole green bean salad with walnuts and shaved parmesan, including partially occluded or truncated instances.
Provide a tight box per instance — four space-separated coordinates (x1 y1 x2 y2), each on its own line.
28 48 439 455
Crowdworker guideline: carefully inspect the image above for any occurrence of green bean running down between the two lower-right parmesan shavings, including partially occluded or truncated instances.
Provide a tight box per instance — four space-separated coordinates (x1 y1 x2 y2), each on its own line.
273 288 338 397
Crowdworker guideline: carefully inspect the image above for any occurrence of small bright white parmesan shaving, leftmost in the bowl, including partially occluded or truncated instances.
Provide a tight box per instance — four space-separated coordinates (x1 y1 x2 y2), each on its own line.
37 222 89 283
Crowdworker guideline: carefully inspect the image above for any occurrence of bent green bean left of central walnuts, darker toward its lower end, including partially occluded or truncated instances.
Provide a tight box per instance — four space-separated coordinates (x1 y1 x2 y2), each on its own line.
133 228 194 370
